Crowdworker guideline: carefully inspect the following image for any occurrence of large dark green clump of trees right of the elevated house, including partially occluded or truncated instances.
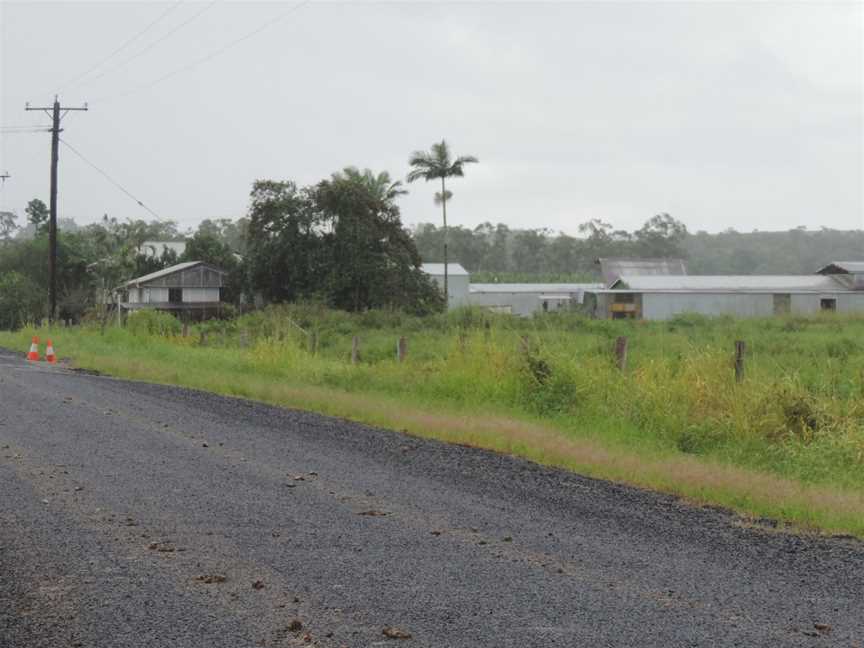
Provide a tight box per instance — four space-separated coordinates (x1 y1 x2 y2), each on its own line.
245 167 441 312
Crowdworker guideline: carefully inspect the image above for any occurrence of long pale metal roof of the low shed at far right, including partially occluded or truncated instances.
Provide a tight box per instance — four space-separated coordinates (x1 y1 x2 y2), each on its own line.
610 275 845 292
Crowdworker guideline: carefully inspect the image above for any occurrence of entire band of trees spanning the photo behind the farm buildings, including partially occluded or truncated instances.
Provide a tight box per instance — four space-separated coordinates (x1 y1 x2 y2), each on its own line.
0 180 864 327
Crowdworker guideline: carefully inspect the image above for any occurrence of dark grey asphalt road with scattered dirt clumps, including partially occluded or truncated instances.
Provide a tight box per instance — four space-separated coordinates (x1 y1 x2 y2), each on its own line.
0 353 864 648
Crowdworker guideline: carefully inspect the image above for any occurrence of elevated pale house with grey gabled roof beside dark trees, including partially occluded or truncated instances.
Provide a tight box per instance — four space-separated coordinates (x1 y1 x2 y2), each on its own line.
117 261 226 319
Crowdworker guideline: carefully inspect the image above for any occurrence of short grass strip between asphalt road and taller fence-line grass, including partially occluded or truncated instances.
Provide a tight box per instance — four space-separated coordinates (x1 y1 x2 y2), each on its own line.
0 316 864 538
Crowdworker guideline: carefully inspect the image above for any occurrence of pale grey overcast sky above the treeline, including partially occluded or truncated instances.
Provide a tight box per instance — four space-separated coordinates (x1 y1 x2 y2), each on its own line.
0 0 864 234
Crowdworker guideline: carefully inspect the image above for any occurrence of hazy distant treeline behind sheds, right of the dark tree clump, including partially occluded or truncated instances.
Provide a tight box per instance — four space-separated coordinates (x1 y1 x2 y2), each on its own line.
413 219 864 282
